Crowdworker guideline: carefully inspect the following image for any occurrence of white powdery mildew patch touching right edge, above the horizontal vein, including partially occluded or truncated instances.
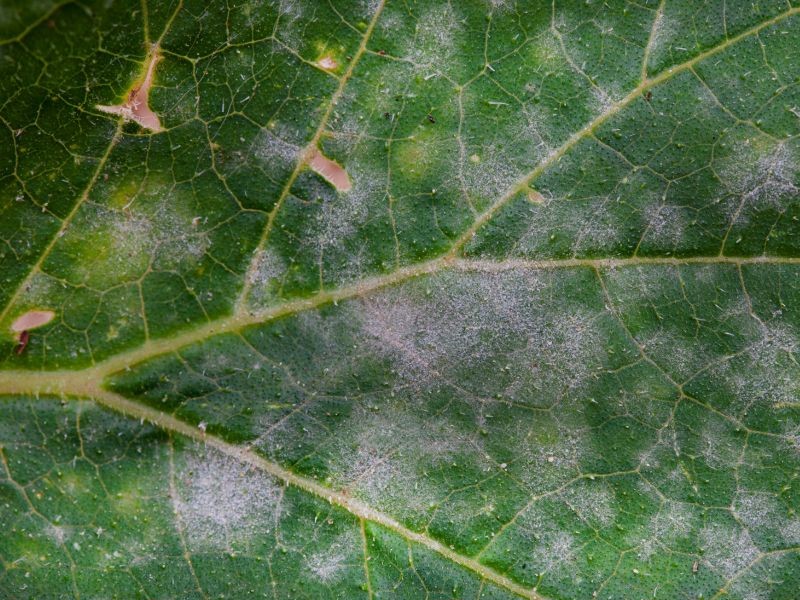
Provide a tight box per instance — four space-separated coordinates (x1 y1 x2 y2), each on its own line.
719 140 800 222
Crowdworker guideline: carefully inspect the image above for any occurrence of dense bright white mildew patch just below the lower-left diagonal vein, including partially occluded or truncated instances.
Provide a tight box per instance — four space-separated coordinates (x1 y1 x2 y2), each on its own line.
172 448 281 548
